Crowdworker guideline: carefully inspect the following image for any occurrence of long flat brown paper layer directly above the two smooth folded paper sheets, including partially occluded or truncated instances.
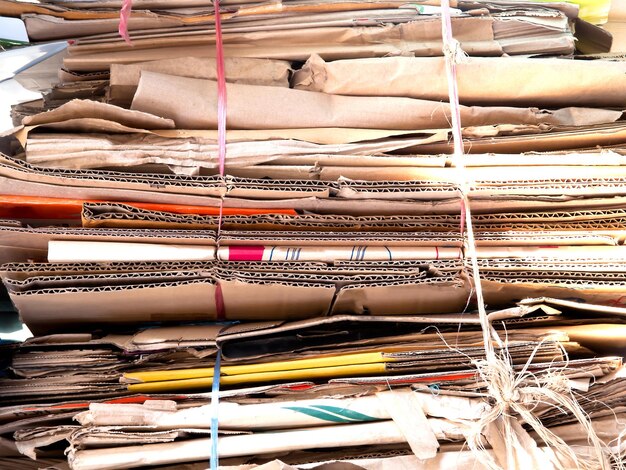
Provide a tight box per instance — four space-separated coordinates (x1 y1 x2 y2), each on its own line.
59 16 502 71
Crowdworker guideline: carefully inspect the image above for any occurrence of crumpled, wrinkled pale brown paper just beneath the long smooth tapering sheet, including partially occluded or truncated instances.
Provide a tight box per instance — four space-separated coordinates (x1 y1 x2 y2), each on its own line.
23 131 444 175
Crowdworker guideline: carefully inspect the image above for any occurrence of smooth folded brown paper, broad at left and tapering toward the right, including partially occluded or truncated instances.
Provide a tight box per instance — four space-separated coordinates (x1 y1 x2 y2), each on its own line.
132 72 622 129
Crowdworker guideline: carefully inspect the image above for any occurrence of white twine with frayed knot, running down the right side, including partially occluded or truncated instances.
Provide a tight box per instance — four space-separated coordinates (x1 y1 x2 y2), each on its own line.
441 0 623 470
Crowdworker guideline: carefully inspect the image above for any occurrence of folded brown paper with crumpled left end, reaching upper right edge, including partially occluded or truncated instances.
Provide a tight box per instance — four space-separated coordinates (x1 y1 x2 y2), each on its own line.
292 55 626 107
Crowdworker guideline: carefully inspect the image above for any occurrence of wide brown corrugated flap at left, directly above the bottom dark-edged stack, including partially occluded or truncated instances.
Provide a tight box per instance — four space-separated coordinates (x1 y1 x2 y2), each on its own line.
10 274 370 334
